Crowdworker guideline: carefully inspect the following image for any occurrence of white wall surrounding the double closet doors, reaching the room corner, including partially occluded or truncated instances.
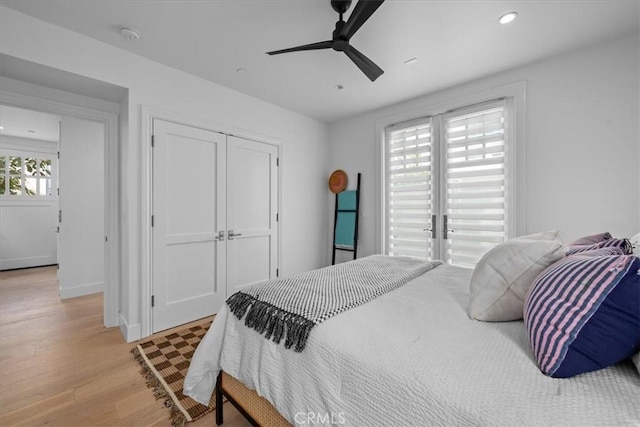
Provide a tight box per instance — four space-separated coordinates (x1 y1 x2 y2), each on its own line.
0 6 328 340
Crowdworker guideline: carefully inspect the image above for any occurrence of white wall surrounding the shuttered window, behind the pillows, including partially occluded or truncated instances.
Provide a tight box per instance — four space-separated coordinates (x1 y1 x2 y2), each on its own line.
327 34 640 256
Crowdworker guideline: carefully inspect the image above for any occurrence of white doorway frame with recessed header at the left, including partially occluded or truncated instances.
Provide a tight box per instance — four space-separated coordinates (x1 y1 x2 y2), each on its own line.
0 69 127 327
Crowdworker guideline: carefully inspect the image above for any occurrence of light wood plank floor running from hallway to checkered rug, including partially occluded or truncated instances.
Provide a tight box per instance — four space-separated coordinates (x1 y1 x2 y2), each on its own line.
0 267 249 427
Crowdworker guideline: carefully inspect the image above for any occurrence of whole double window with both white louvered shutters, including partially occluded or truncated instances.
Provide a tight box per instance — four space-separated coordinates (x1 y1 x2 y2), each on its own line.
384 100 513 268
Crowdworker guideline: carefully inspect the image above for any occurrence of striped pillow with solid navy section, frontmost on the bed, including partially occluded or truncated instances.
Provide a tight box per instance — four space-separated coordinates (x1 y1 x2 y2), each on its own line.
524 255 640 378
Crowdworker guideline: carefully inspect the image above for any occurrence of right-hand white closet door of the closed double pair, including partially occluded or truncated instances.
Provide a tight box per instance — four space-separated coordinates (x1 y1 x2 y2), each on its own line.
227 136 278 295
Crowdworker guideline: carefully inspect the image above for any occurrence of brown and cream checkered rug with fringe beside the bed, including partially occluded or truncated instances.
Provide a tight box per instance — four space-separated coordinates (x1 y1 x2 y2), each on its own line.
131 322 215 426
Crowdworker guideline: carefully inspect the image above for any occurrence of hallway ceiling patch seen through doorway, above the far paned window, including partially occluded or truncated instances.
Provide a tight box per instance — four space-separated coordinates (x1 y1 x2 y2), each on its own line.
0 105 60 142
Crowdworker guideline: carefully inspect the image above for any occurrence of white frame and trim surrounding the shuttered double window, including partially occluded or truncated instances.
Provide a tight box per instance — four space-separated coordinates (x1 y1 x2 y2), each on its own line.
375 81 526 260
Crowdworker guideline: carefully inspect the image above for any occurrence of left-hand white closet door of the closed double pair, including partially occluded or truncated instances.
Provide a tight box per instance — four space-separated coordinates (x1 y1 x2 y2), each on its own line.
152 120 226 332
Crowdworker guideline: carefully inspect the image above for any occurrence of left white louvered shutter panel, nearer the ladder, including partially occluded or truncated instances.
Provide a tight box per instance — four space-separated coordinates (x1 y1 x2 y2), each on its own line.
385 118 434 259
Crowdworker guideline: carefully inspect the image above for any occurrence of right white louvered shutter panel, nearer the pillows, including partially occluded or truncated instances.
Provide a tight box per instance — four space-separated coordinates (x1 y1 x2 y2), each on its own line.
443 101 507 267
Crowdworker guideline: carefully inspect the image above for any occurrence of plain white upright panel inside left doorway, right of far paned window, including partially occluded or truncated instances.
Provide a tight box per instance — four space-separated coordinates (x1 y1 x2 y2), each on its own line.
58 116 105 298
